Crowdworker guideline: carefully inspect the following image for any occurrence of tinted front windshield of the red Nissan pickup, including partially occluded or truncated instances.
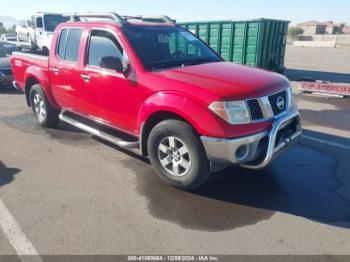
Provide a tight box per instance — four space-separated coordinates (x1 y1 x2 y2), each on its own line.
123 25 222 71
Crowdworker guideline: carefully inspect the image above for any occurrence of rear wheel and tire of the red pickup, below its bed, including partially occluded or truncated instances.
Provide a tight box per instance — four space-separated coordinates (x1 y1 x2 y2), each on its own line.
29 84 59 128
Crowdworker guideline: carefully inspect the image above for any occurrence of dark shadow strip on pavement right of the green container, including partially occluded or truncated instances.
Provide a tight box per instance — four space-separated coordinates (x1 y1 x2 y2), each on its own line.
284 69 350 84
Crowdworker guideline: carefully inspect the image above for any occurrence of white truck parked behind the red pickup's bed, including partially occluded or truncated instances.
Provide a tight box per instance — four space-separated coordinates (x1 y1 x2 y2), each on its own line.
16 12 69 54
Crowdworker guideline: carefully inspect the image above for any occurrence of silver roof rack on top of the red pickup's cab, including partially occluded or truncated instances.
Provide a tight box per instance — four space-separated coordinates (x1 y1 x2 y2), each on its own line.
65 12 176 25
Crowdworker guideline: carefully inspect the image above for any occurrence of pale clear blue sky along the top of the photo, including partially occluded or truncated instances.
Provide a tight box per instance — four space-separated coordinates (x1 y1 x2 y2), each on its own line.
0 0 350 23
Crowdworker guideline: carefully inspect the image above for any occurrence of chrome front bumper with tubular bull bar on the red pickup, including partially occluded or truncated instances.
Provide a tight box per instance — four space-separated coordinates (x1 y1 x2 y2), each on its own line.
201 112 302 170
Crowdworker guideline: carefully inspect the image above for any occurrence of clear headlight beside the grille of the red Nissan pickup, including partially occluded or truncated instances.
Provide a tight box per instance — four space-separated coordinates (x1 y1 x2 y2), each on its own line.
209 100 251 125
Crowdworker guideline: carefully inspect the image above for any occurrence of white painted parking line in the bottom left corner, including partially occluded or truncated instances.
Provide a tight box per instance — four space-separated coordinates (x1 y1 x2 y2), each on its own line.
0 199 42 262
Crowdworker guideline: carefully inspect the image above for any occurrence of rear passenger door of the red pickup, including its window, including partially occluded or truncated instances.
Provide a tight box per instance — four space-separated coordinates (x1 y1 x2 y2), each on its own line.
49 28 84 113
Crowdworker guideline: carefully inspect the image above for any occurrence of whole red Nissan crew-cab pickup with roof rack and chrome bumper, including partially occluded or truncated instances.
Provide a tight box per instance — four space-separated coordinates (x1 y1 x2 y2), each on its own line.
11 13 301 190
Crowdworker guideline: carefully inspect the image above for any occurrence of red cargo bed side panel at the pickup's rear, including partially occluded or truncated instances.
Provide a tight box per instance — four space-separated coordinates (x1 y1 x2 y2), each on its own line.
11 52 49 91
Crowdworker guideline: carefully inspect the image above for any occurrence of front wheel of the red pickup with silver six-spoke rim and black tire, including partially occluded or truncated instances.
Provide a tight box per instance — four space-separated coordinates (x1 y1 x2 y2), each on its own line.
147 120 210 190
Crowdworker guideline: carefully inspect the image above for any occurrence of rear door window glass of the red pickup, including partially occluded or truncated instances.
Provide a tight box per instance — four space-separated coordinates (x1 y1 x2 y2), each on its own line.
57 29 83 62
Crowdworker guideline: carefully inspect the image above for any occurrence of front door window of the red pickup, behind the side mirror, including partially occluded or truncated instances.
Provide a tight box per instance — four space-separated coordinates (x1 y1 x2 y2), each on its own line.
87 30 123 67
